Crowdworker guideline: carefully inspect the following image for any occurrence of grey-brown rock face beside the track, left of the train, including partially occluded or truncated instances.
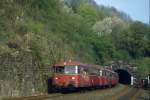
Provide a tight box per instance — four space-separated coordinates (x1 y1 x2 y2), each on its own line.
0 51 47 97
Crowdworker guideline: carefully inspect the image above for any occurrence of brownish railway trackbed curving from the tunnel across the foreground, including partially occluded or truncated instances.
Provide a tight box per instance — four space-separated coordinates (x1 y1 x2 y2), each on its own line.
3 84 150 100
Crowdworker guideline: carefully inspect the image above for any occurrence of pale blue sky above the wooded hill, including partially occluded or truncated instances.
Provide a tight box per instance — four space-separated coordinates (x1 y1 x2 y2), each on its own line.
95 0 150 23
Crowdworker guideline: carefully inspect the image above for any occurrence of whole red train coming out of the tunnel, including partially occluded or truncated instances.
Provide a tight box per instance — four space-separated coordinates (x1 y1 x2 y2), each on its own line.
49 60 118 90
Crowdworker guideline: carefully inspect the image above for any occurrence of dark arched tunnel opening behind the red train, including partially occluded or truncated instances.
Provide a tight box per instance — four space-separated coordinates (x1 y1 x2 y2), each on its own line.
115 69 131 85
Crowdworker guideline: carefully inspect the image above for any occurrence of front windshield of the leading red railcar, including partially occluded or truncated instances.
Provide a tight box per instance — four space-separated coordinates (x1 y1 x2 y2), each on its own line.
54 66 78 74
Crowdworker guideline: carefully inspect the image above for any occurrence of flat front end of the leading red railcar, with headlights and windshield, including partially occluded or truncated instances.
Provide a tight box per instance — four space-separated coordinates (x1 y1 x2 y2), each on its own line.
53 65 79 90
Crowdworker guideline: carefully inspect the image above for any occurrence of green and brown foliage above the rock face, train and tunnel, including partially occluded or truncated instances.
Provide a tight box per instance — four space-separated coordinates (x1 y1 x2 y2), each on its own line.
0 0 150 75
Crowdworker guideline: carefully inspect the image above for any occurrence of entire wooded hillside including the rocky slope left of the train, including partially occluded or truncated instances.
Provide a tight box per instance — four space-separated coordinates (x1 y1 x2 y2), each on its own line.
0 0 150 96
